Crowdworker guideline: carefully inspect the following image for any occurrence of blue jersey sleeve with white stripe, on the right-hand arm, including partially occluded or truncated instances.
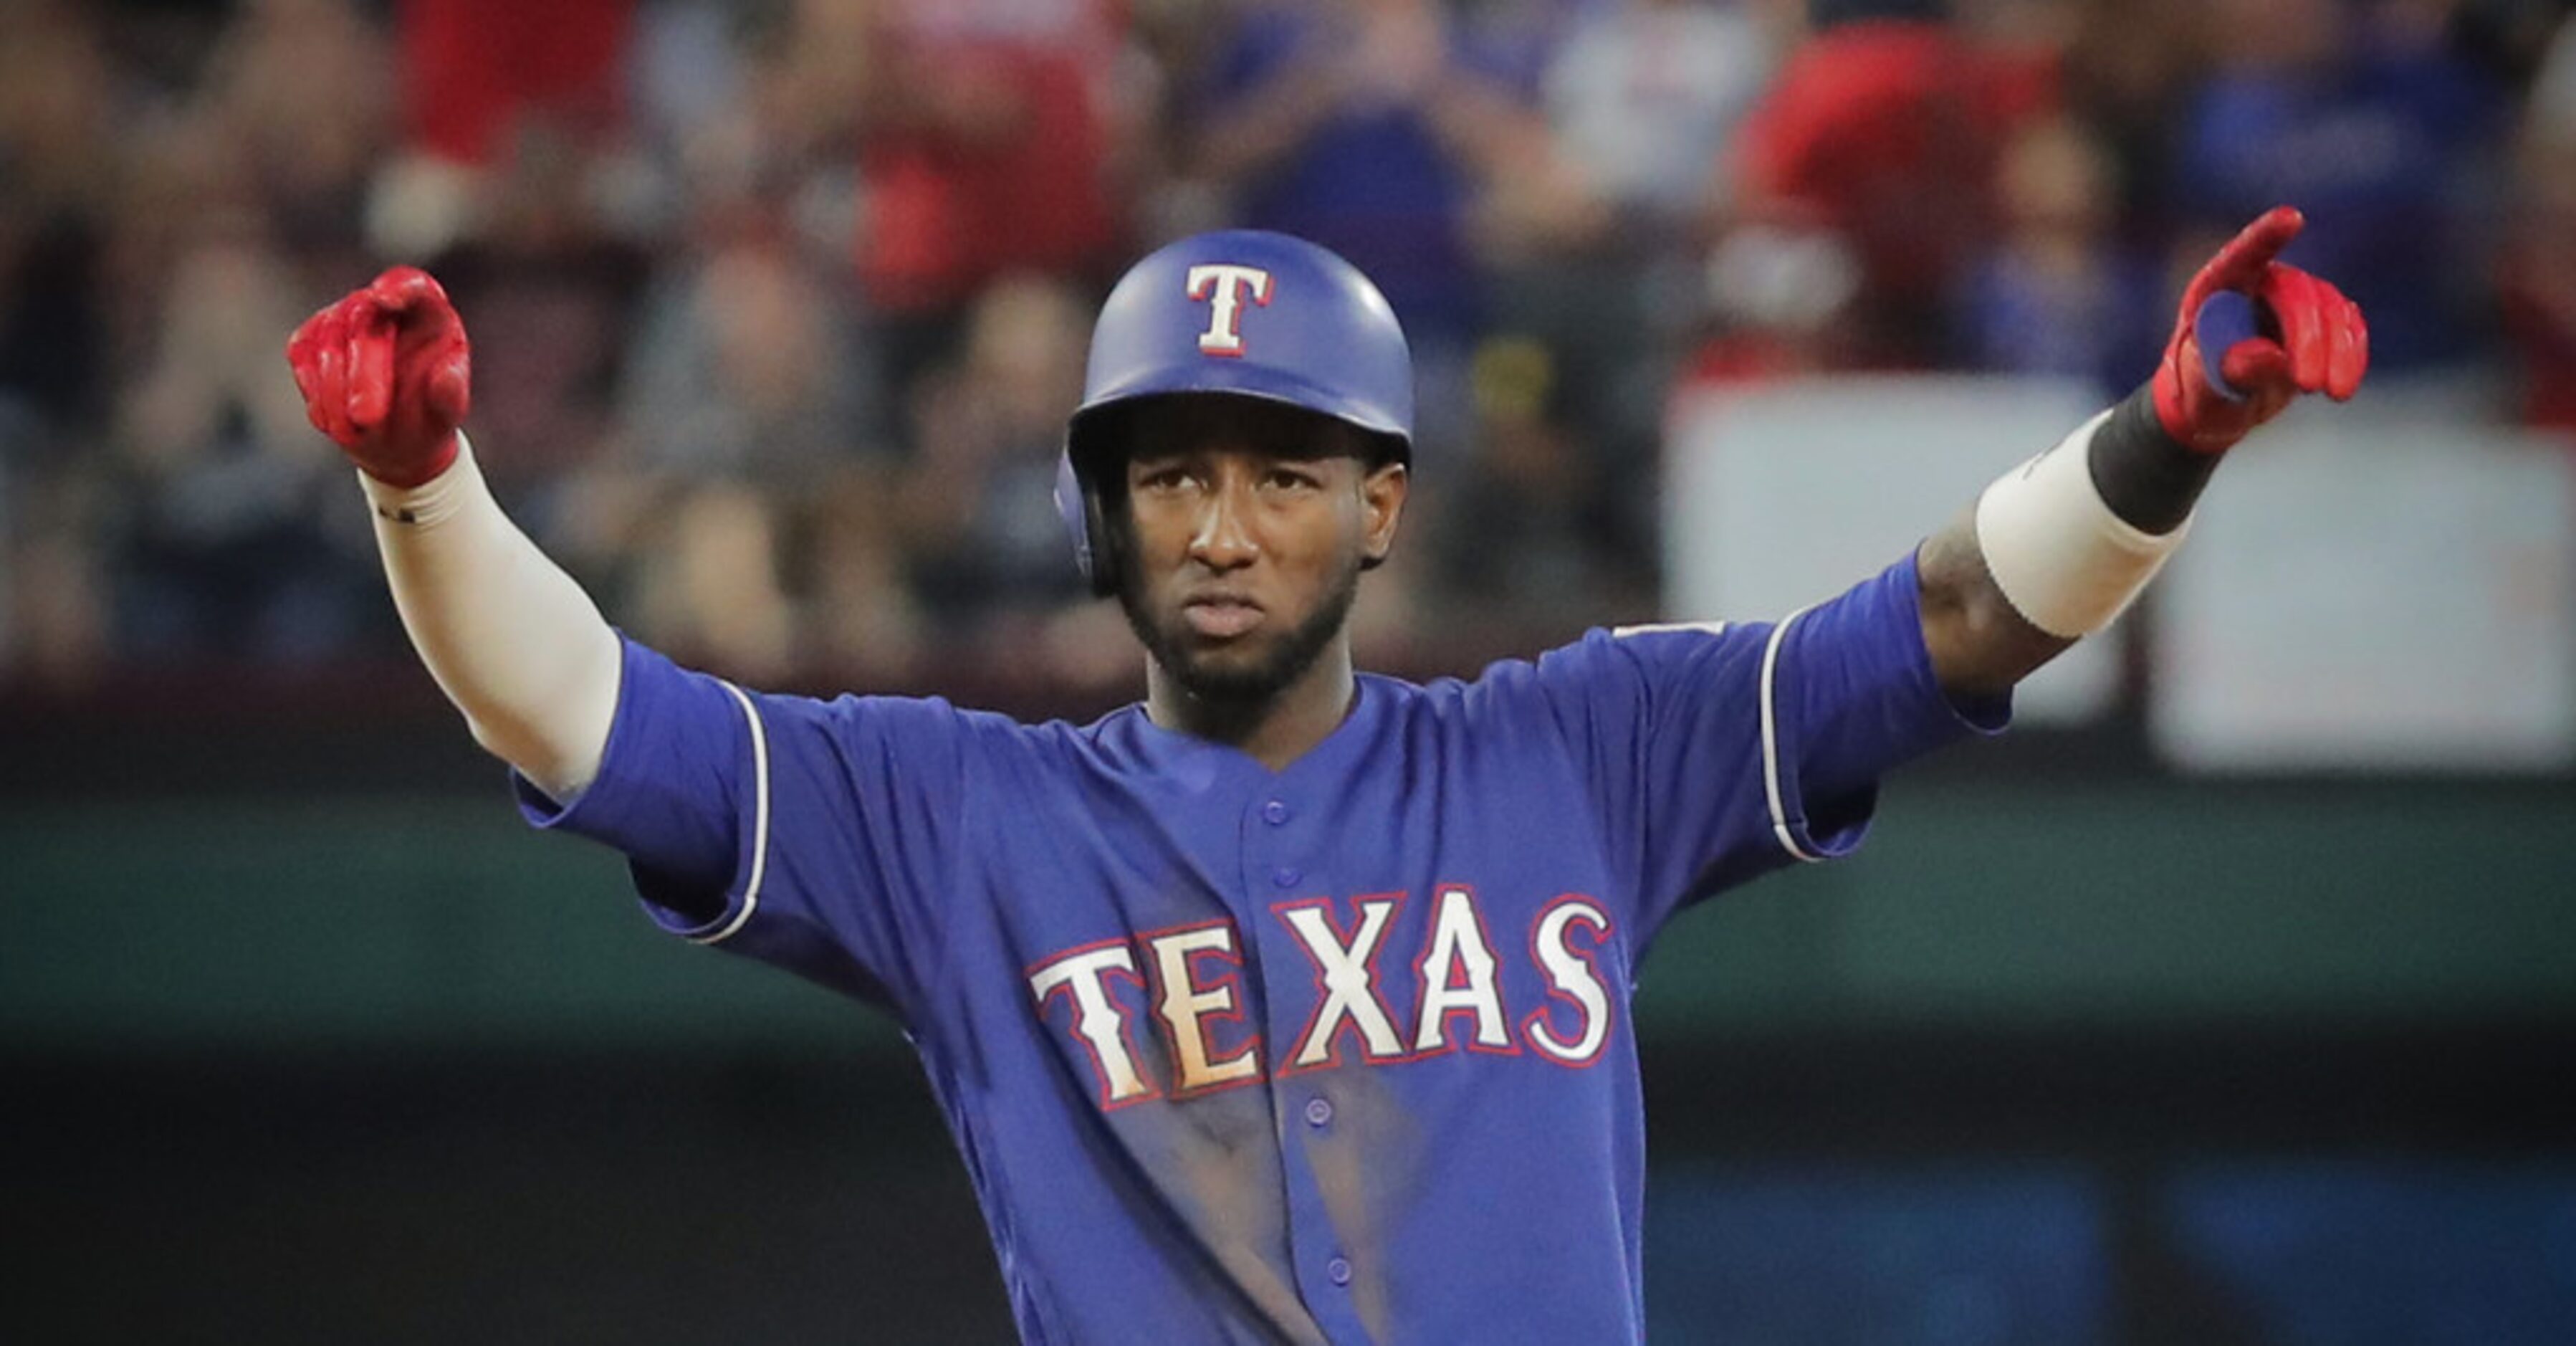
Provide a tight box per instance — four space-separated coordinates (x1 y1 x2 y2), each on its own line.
1541 555 2012 931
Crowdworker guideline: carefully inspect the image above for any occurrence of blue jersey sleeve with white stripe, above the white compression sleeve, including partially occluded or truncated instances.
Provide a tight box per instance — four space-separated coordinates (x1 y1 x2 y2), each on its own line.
518 639 964 1013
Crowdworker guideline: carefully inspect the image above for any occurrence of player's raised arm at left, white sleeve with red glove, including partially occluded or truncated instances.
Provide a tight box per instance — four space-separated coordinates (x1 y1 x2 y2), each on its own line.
286 266 621 799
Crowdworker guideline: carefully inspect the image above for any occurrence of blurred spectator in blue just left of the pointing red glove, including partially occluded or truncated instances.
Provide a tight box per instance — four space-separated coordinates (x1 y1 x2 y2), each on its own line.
1963 118 2172 400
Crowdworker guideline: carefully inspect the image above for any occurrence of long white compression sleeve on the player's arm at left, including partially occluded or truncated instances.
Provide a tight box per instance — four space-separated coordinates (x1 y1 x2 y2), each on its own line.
358 436 623 802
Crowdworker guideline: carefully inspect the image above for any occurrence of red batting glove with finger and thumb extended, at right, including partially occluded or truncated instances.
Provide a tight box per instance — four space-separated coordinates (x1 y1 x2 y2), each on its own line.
2153 206 2370 454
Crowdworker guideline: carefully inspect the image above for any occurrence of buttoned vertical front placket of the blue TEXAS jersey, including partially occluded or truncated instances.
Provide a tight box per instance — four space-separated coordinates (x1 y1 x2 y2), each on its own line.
1242 779 1373 1341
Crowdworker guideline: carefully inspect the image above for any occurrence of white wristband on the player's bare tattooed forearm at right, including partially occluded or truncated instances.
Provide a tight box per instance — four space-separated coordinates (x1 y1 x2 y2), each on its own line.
1976 413 2192 639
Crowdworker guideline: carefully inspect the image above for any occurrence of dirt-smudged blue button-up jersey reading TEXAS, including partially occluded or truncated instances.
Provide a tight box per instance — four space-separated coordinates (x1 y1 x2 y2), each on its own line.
525 549 2004 1343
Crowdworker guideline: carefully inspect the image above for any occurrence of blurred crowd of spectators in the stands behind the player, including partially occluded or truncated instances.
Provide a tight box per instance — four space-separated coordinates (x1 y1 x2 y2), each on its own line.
0 0 2576 689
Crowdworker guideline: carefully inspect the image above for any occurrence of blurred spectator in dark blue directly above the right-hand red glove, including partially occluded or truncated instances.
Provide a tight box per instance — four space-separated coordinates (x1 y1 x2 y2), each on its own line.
2174 0 2506 381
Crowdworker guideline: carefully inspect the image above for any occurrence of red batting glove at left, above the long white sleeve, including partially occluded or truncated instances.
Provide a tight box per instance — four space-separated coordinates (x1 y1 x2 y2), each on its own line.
286 266 471 487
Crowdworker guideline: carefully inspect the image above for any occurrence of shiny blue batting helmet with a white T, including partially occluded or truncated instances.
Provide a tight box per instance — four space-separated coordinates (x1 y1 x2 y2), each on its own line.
1056 229 1414 596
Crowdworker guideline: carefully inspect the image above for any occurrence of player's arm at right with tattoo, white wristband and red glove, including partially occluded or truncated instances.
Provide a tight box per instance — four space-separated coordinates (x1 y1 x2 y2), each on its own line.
1917 206 2370 696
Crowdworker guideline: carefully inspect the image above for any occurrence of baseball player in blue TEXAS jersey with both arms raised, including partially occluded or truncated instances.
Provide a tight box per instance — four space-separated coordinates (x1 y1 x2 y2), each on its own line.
289 209 2367 1343
